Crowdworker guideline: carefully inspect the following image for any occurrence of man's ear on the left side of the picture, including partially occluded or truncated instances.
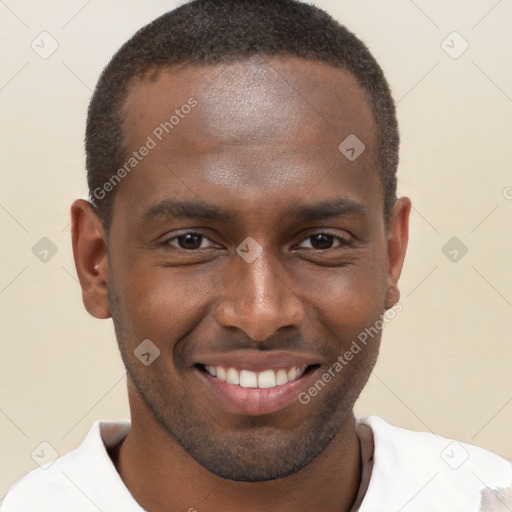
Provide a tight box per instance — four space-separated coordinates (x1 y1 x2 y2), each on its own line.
71 199 110 318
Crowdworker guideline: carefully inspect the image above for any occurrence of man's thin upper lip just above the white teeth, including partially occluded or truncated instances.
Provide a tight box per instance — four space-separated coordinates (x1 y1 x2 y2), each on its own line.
197 350 320 372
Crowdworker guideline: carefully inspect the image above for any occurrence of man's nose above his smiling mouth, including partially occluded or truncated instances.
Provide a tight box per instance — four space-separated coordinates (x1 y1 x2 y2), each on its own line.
215 251 304 341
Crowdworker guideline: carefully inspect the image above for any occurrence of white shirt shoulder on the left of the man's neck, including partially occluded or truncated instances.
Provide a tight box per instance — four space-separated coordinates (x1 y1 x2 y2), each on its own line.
1 421 129 512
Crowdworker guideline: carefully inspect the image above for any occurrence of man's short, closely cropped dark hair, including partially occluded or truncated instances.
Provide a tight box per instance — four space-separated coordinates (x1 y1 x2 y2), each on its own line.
85 0 399 230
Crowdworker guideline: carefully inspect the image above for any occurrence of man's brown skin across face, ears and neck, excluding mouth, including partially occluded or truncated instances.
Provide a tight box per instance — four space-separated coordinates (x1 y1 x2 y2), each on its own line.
72 58 410 512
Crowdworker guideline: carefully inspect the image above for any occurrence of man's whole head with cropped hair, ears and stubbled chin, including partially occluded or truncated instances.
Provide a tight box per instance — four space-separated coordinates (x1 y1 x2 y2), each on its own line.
72 0 410 481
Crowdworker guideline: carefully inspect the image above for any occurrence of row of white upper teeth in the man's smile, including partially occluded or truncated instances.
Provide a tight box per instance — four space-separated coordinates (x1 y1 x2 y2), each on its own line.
204 366 306 388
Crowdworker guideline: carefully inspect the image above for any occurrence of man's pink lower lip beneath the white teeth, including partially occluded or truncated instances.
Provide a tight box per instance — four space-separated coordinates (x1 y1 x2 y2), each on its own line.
196 368 316 416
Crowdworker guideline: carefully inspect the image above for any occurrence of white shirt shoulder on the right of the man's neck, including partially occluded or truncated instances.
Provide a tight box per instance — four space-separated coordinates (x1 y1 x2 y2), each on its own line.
358 416 512 512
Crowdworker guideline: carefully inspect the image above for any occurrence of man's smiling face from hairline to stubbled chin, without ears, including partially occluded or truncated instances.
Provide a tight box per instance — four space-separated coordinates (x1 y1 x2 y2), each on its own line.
108 58 404 481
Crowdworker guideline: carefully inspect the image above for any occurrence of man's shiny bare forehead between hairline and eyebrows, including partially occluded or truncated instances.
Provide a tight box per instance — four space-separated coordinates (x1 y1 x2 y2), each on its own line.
116 58 378 218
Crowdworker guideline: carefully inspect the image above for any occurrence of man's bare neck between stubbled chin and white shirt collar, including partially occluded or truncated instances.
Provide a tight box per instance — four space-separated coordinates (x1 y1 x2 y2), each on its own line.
112 390 362 512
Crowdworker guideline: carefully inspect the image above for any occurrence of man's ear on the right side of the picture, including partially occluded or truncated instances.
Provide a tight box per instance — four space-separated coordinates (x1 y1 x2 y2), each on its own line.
385 197 411 309
